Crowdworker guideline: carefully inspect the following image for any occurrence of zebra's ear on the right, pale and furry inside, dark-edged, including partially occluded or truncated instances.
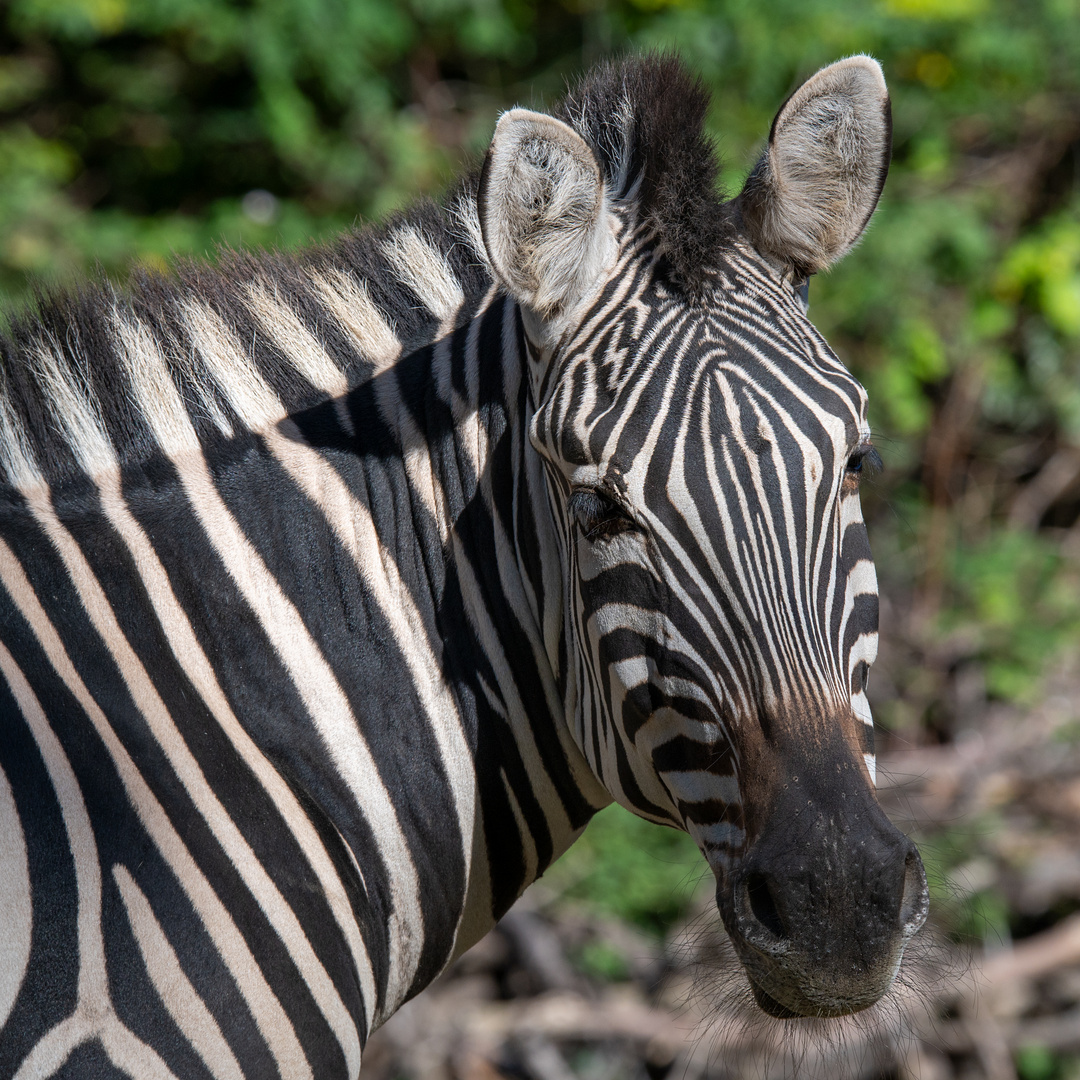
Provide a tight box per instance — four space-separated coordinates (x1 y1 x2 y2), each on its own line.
739 56 892 273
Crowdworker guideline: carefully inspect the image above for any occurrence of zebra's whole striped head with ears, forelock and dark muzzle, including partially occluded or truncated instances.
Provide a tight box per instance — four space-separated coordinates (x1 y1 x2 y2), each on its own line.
478 56 927 1017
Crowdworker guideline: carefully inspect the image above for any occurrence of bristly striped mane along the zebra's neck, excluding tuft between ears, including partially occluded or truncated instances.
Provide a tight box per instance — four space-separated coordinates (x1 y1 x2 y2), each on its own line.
0 190 491 486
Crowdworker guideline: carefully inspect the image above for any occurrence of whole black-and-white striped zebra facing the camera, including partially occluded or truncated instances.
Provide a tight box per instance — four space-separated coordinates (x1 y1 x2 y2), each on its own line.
0 55 928 1080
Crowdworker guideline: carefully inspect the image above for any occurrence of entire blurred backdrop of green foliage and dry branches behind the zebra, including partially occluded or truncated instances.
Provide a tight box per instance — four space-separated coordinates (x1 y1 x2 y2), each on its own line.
6 0 1080 1080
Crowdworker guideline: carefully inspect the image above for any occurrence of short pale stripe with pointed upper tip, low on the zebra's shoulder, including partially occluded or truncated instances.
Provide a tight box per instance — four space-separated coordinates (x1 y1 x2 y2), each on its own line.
112 863 244 1080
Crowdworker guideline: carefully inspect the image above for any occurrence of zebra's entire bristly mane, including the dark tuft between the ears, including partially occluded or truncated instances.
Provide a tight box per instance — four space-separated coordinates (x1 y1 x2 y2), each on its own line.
0 54 731 485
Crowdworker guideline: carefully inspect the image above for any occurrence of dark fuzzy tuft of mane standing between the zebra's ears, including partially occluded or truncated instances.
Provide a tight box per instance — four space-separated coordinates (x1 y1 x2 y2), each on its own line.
555 53 734 299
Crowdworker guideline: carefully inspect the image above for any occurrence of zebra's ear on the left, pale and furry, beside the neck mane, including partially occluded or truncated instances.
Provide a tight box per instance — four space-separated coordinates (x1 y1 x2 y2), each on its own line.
477 109 617 328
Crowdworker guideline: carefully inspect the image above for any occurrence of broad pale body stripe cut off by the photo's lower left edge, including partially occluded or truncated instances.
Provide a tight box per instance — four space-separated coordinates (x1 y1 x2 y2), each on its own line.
0 756 33 1030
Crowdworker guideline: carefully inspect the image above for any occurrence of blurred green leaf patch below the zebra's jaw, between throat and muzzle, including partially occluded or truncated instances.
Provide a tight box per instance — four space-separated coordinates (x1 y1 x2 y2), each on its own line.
543 804 712 937
